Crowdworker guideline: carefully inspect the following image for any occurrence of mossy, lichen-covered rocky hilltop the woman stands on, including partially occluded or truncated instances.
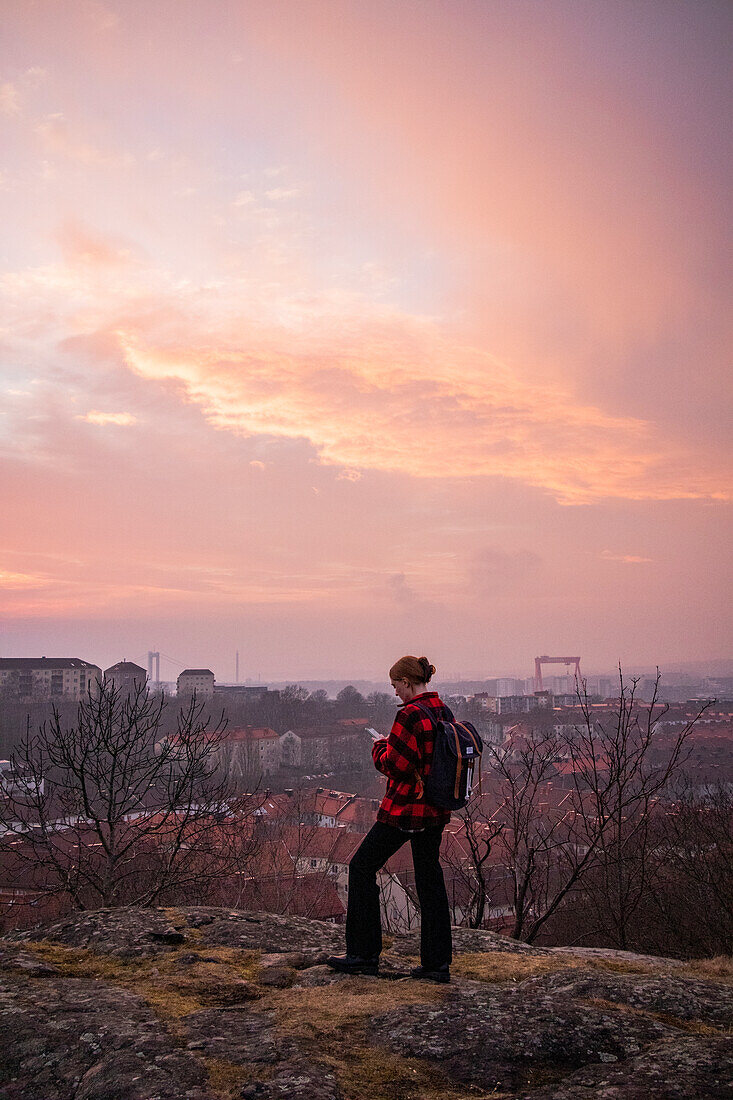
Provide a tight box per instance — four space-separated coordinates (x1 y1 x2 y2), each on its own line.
0 908 733 1100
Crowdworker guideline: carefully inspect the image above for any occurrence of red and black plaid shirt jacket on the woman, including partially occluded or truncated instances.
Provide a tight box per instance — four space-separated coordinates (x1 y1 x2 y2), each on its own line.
372 691 450 832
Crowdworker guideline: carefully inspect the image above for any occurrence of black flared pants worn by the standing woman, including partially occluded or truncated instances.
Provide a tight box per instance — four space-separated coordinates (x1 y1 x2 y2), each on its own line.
346 822 452 969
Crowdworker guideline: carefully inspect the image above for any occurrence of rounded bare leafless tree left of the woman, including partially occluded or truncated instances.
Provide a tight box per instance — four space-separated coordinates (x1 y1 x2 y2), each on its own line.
0 681 245 909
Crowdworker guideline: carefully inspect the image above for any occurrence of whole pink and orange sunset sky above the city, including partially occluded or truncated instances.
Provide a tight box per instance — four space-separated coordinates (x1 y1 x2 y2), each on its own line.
0 0 733 681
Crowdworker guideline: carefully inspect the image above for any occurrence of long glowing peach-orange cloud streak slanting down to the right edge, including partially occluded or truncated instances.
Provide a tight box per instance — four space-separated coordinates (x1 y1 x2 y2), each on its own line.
118 307 730 504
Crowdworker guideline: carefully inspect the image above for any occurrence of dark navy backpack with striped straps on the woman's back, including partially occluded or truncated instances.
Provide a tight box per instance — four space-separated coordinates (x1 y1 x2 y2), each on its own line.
413 703 483 810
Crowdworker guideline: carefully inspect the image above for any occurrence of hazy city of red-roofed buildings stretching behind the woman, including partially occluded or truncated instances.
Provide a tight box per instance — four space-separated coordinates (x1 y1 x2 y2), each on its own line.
0 651 733 947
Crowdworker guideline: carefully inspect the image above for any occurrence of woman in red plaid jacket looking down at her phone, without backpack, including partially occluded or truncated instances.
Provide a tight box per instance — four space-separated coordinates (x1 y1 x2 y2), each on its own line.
328 657 451 982
